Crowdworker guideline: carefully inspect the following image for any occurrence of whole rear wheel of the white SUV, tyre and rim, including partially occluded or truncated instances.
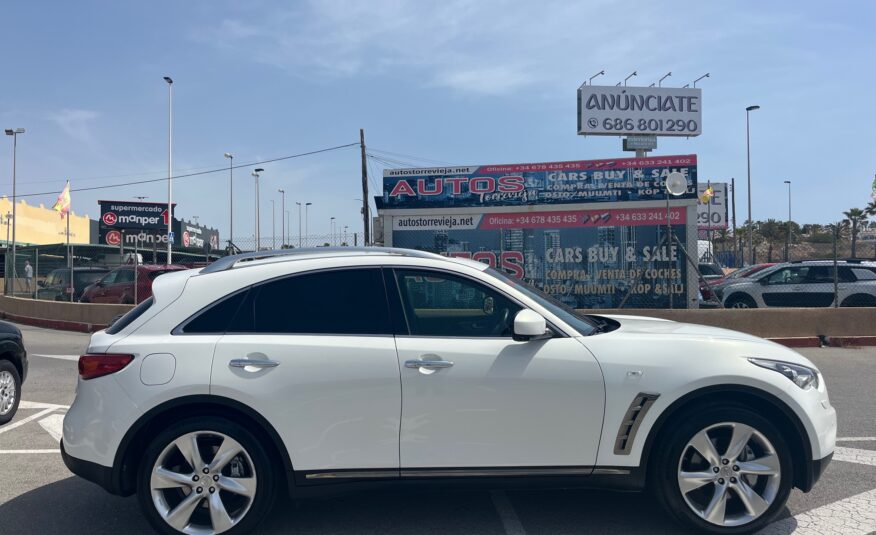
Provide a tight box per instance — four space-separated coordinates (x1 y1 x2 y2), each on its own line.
137 416 284 535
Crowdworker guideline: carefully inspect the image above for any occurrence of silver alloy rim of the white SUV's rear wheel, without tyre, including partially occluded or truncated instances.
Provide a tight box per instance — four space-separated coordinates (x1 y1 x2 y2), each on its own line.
149 431 257 535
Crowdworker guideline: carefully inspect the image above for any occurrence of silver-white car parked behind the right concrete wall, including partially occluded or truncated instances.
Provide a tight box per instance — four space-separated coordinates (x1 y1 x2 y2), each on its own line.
712 260 876 308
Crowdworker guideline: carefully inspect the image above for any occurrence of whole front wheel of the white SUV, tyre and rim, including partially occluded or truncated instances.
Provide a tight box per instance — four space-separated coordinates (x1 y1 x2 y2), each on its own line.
649 404 794 535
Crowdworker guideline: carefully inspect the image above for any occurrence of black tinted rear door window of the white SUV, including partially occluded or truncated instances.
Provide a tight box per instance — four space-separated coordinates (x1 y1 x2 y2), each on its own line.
228 268 392 335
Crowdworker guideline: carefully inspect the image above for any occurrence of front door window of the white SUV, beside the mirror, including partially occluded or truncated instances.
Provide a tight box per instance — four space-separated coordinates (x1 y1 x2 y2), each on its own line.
396 270 521 337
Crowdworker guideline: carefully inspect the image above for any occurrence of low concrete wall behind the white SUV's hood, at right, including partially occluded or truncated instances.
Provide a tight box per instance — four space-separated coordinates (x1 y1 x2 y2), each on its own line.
584 308 876 338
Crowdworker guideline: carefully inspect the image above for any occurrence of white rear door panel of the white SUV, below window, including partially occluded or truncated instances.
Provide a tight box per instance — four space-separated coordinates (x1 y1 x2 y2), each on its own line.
211 335 401 470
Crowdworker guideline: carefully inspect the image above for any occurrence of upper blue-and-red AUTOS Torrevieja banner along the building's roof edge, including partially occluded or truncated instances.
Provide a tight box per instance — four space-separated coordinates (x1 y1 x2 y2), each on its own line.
376 155 697 209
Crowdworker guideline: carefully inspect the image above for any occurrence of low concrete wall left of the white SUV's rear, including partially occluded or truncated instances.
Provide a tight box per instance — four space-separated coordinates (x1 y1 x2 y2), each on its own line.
0 295 133 332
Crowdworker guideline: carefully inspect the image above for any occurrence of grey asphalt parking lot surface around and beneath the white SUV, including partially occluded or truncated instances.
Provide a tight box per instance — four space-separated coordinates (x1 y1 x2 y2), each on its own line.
0 326 876 535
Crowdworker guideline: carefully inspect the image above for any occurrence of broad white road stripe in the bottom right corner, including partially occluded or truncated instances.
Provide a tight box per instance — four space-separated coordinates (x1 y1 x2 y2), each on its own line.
758 490 876 535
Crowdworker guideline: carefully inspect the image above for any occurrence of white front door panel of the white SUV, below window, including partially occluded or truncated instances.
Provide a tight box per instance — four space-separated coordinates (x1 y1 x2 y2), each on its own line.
396 336 605 468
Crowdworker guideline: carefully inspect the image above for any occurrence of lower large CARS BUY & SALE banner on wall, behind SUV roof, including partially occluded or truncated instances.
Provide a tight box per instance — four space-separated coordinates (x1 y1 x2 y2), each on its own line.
392 207 688 308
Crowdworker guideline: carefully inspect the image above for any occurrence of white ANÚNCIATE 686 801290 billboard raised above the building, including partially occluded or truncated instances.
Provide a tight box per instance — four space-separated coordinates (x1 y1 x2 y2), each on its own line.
578 85 702 136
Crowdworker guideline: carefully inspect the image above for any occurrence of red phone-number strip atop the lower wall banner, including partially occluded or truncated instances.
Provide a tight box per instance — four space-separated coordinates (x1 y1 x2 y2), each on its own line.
478 208 687 229
